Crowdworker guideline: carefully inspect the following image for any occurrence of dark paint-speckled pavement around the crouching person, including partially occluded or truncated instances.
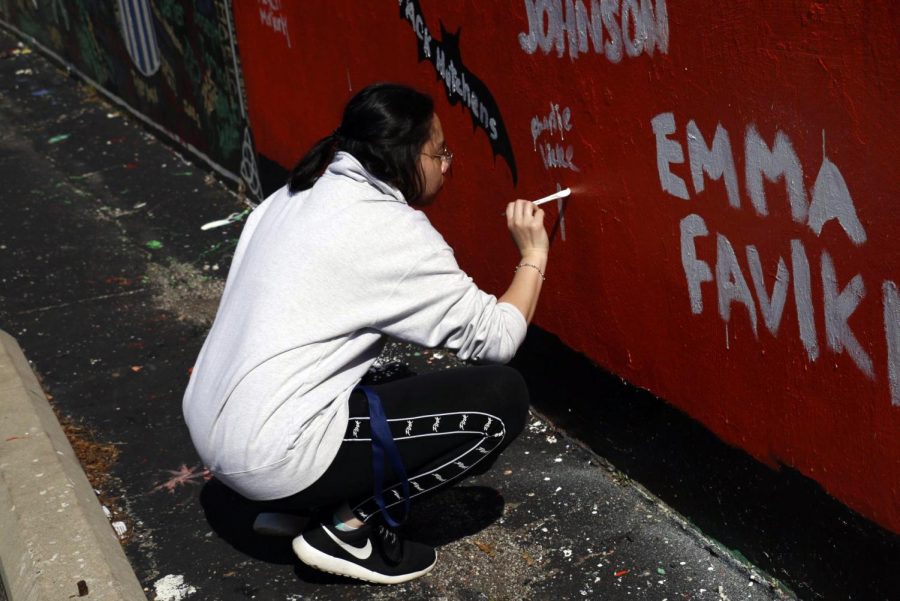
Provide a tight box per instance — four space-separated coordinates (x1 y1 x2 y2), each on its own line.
0 28 791 601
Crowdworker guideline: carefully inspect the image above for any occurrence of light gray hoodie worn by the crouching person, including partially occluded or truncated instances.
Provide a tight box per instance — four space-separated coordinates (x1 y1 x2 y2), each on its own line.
183 152 527 500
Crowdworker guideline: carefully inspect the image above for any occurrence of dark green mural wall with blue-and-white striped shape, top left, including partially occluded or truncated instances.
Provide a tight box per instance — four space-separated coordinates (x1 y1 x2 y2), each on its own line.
0 0 261 198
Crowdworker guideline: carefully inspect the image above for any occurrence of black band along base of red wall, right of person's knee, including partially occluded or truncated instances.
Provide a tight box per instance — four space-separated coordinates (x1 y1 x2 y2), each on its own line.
514 327 900 599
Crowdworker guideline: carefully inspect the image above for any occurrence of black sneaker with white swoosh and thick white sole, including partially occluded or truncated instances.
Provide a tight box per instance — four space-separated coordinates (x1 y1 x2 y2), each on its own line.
293 522 437 584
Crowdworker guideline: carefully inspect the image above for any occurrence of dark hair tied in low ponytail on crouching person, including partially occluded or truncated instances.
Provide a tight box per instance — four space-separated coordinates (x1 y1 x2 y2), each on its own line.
288 83 434 203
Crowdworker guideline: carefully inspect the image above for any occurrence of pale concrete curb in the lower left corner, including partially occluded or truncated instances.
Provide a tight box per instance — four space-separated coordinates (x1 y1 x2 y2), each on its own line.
0 330 146 601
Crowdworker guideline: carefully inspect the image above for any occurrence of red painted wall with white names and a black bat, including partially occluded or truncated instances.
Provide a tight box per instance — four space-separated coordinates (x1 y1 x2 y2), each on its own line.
234 0 900 532
